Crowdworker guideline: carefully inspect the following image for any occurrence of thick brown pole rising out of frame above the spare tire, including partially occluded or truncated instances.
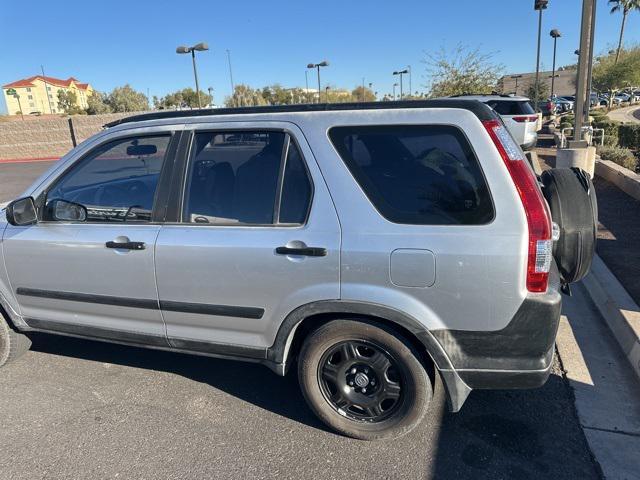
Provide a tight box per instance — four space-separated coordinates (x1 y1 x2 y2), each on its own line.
569 0 596 144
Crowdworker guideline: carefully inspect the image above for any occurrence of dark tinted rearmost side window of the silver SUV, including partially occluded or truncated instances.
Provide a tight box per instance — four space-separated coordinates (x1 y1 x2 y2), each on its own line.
329 125 493 225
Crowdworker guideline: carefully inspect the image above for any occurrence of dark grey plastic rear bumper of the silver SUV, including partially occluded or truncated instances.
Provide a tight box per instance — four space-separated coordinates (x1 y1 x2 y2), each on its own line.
432 272 562 389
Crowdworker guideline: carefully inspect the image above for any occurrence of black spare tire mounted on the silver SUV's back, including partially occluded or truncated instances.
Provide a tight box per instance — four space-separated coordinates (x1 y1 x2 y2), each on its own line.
540 168 598 283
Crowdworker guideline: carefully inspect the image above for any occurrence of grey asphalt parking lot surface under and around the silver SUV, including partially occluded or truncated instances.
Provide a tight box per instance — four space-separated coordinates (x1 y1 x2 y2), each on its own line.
0 162 599 480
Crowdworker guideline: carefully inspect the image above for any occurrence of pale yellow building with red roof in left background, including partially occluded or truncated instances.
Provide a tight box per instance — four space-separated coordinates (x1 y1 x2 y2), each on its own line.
2 75 93 115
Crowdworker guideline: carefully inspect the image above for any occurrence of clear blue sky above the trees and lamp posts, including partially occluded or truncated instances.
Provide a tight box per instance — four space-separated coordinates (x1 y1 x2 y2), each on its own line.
0 0 640 111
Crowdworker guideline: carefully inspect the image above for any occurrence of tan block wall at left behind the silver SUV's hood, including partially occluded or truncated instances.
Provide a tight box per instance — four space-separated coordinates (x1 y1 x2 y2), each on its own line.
0 112 145 160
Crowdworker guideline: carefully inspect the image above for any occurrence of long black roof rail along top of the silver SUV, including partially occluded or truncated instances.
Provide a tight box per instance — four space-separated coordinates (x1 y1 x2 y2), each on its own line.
104 98 494 128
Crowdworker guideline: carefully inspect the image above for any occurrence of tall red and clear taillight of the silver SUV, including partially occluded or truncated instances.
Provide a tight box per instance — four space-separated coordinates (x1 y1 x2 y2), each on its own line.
482 120 553 292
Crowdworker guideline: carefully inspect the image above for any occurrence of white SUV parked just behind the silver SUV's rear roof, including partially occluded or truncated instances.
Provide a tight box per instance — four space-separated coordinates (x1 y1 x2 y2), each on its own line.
451 95 538 150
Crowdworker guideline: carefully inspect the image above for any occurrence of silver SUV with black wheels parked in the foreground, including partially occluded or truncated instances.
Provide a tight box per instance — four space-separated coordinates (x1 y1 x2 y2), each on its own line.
0 99 592 439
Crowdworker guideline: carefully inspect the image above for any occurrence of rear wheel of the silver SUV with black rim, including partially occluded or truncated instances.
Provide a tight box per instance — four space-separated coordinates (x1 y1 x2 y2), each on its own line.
298 320 433 440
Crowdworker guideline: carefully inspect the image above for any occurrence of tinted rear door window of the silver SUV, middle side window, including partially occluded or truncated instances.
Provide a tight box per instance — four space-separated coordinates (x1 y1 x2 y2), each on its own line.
183 131 312 225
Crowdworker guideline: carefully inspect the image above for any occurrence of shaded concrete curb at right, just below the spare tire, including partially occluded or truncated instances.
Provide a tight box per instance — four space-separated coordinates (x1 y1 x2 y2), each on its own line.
582 255 640 380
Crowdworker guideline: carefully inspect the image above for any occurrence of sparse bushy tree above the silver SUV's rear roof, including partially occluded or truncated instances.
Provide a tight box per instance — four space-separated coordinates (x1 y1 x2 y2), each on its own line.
423 45 504 97
